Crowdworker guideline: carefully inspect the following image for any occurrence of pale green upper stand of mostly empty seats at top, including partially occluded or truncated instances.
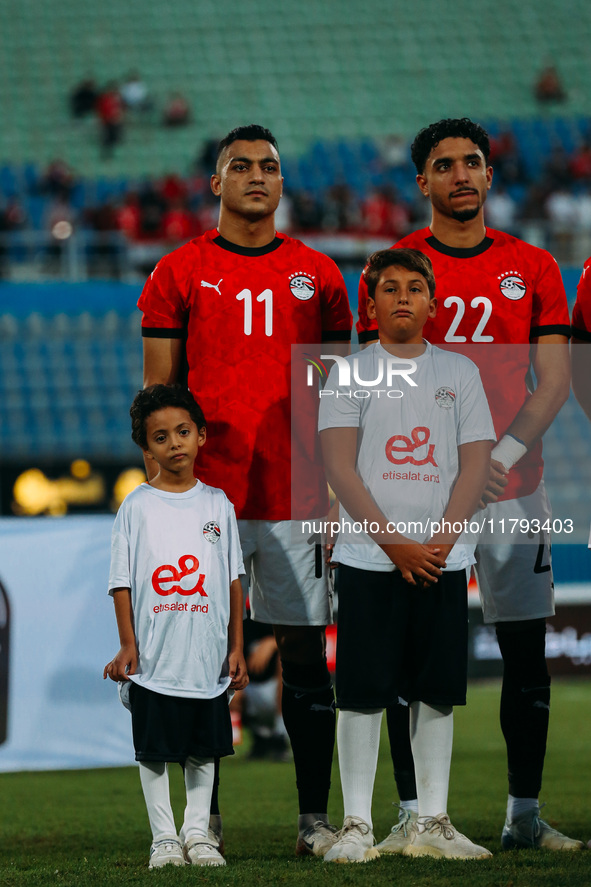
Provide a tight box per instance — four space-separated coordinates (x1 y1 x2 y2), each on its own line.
0 0 591 177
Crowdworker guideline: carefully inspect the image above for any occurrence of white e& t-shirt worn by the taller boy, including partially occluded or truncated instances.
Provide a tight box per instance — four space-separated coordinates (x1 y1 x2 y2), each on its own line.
319 342 495 572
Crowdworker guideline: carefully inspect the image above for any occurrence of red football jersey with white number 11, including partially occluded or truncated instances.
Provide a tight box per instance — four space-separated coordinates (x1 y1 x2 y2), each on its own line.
138 229 353 520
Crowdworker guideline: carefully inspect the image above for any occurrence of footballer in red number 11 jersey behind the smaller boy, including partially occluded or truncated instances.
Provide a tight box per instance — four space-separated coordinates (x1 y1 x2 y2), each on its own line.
139 125 352 856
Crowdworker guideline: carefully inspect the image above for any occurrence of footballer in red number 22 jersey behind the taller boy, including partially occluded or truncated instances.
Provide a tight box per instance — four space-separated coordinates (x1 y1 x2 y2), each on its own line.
358 118 584 854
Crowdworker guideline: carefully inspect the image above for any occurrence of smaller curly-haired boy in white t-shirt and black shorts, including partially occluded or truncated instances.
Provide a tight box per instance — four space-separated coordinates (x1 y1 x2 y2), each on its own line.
103 385 248 869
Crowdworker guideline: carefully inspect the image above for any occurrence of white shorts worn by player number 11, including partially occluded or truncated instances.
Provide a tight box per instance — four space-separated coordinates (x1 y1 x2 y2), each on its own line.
238 520 332 625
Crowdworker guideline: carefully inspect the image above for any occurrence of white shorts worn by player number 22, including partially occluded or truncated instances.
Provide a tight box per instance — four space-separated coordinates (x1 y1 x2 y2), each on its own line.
475 481 554 623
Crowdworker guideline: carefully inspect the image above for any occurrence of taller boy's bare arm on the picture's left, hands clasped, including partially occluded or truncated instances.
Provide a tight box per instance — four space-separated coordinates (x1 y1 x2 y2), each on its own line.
320 428 445 585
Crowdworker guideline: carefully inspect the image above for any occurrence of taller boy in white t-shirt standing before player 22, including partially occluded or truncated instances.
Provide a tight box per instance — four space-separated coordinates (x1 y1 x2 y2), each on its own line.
319 249 494 862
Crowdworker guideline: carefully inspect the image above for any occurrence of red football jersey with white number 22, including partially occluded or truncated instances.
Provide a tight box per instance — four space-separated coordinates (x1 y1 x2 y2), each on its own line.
357 228 570 499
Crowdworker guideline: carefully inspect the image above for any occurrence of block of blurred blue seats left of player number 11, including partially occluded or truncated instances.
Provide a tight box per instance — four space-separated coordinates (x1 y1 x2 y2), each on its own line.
0 311 142 462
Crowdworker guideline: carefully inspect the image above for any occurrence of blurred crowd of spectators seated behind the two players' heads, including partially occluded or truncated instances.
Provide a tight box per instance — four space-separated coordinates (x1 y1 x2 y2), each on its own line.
0 118 591 263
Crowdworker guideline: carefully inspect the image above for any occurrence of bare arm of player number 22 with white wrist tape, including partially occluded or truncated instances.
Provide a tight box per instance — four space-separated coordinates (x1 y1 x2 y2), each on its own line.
482 333 570 504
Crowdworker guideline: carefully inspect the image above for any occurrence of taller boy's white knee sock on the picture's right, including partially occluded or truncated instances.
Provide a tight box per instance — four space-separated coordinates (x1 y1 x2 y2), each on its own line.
410 702 453 816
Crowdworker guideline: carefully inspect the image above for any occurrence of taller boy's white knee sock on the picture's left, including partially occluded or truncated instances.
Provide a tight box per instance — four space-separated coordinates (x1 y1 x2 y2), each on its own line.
337 708 383 826
